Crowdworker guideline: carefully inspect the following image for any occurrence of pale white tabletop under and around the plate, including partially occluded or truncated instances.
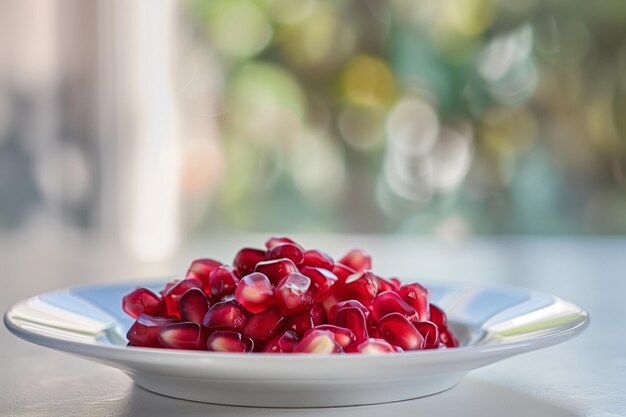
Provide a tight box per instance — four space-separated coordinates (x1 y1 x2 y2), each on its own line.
0 236 626 417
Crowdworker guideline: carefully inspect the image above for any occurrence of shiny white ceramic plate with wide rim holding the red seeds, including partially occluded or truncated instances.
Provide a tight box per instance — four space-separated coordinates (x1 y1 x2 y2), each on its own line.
4 280 588 407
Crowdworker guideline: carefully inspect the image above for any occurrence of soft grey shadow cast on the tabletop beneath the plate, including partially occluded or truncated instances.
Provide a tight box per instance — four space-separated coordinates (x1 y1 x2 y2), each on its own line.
124 377 578 417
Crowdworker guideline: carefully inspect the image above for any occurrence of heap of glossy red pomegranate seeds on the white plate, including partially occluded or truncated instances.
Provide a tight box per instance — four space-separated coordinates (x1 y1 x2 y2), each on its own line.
122 237 458 354
